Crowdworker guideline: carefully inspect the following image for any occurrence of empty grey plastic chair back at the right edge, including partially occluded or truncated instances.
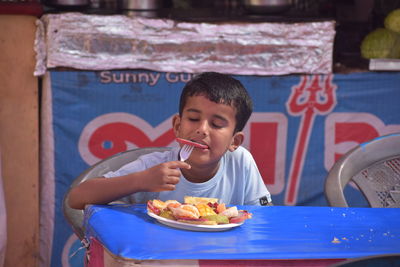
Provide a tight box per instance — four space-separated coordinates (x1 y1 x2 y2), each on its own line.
325 133 400 207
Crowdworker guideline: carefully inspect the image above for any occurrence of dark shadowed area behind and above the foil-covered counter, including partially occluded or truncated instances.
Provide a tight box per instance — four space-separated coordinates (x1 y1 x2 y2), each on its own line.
0 0 400 73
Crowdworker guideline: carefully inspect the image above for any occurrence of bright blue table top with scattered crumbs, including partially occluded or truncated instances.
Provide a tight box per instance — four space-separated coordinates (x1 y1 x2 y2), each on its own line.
85 205 400 260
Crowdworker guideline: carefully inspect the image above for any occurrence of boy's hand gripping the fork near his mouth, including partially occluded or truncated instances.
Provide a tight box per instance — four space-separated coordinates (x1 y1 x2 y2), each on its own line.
144 161 190 192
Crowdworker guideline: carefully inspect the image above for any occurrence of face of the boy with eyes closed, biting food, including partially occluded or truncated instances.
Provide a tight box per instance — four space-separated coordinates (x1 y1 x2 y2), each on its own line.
173 95 243 168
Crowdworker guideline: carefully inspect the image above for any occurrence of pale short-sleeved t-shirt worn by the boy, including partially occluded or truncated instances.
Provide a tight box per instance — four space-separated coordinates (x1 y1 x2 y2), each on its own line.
104 147 271 205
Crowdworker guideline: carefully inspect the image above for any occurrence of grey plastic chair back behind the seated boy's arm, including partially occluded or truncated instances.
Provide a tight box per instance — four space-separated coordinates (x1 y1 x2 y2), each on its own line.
62 147 171 240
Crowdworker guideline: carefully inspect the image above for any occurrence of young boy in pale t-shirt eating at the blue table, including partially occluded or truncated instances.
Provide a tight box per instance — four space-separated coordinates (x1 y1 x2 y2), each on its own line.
69 72 271 209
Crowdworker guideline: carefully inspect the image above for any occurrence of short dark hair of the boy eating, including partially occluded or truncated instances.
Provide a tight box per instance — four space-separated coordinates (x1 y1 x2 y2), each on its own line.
179 72 253 133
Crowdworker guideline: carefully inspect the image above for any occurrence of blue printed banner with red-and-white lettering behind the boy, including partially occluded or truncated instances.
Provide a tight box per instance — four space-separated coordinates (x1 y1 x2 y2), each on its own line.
41 70 400 267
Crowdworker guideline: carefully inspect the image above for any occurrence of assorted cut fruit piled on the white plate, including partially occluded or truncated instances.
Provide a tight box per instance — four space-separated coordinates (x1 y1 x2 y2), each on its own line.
147 196 252 225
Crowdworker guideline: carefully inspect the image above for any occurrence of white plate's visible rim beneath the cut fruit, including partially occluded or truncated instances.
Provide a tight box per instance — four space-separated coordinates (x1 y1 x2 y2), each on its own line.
147 211 243 232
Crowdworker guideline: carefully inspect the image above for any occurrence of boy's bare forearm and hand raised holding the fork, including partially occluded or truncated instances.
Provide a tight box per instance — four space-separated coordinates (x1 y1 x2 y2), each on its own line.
68 161 190 209
